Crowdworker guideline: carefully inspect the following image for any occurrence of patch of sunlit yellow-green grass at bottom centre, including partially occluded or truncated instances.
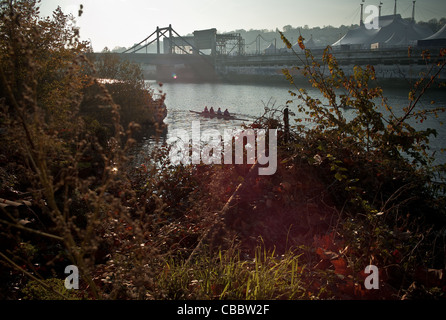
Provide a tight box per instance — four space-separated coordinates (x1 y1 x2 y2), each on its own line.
158 245 311 300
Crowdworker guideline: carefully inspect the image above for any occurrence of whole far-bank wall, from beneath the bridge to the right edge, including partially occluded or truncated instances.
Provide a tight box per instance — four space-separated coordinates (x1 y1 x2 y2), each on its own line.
125 47 446 83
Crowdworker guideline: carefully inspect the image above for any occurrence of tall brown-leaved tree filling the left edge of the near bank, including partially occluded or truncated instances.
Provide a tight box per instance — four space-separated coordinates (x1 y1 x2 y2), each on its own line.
0 0 159 299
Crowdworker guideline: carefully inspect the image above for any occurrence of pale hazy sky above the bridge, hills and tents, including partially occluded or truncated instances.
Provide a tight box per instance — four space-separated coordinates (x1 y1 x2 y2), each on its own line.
40 0 446 51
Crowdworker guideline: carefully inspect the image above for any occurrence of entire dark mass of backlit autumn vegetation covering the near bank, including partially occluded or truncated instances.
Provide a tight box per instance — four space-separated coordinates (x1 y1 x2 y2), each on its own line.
0 0 446 299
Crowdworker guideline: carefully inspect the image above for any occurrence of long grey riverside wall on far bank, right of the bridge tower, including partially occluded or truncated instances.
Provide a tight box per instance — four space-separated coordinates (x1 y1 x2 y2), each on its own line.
216 48 446 82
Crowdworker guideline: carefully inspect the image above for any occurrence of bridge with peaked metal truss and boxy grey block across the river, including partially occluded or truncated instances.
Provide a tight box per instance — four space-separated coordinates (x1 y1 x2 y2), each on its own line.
88 25 245 81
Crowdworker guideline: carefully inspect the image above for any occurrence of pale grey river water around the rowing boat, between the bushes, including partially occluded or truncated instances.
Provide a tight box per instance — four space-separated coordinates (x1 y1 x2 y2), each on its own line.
138 82 446 163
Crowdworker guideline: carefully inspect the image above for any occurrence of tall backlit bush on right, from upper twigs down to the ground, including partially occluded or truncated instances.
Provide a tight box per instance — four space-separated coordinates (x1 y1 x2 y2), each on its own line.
281 34 446 296
